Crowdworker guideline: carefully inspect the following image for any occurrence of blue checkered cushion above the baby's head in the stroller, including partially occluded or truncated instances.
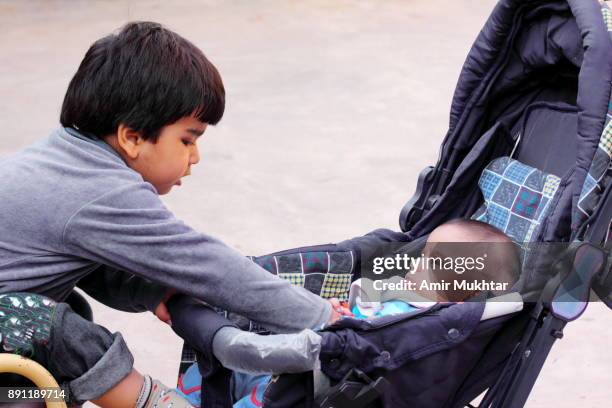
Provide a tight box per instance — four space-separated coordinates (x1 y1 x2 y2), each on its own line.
472 157 561 243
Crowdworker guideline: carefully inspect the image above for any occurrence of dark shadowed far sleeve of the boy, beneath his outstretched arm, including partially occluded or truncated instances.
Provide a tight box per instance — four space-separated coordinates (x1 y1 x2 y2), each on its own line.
77 265 168 313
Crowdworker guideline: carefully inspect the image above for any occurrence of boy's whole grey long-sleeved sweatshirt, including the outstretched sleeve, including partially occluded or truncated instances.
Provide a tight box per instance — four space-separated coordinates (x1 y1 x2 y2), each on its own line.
0 128 331 332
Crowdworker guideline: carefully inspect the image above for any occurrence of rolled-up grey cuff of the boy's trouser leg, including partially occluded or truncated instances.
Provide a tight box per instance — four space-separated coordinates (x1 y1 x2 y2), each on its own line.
67 333 134 402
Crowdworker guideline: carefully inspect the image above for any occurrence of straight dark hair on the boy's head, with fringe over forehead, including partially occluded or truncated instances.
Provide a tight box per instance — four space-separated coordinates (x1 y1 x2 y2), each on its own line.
60 22 225 142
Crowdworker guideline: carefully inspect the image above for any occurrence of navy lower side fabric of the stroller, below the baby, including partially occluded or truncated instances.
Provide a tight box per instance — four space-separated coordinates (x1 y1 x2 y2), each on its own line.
264 302 514 407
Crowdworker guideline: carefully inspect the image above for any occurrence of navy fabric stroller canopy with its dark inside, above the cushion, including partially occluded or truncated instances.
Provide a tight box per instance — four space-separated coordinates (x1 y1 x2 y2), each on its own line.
401 0 612 245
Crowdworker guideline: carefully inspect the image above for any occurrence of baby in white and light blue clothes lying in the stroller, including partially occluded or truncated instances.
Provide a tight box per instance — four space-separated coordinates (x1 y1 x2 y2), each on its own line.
350 219 520 318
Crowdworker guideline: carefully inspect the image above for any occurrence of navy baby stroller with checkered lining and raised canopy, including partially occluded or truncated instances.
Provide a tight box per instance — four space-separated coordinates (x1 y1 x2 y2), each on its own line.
173 0 612 408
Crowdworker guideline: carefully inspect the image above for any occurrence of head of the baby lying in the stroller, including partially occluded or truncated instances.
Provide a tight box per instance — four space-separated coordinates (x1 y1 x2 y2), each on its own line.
416 219 520 302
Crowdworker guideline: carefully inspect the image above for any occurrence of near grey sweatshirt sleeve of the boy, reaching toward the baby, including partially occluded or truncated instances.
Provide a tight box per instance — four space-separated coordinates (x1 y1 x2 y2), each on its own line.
62 183 331 332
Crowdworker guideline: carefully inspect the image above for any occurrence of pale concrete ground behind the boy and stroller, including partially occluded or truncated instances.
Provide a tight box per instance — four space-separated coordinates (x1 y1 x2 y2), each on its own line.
0 0 612 408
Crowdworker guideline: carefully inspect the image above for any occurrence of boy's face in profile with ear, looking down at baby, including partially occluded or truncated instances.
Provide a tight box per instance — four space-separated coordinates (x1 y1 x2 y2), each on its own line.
119 116 207 195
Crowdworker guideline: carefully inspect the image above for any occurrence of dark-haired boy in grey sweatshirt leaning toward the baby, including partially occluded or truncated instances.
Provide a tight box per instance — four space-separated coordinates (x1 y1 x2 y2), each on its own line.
0 22 338 408
